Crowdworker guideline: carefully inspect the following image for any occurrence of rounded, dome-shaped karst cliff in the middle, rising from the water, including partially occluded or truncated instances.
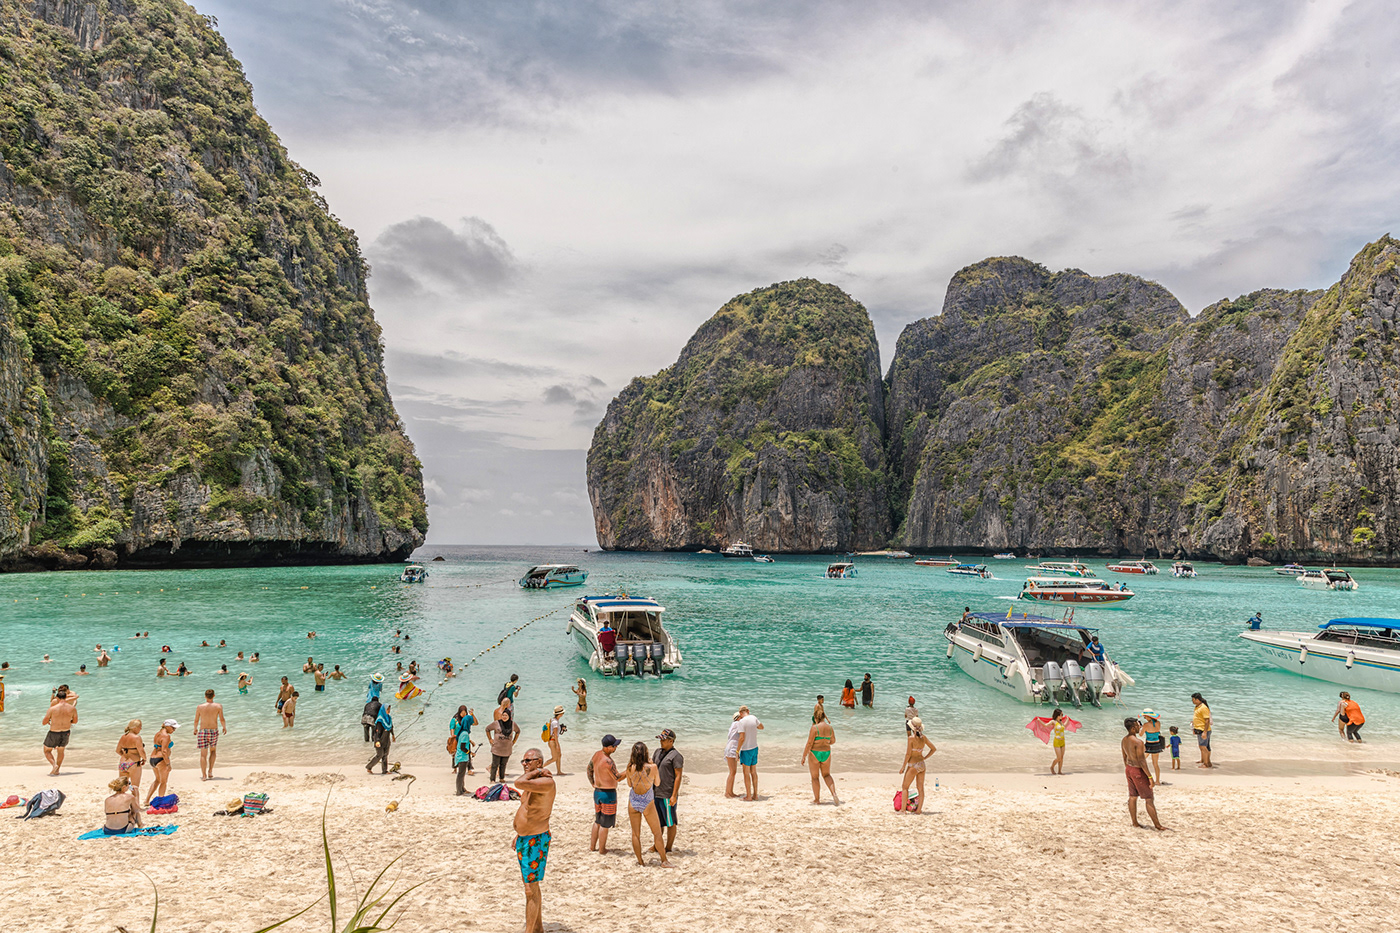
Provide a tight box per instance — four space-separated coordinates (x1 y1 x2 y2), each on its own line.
588 279 890 551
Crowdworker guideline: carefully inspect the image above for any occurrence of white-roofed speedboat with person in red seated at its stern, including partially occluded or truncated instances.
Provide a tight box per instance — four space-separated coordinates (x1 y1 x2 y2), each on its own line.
566 595 680 677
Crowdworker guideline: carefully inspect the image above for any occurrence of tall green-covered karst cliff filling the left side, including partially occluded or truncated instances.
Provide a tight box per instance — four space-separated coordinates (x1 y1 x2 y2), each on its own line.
0 0 427 566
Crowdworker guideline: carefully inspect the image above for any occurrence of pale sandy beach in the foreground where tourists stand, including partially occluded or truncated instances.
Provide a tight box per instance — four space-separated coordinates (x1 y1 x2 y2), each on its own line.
0 755 1400 933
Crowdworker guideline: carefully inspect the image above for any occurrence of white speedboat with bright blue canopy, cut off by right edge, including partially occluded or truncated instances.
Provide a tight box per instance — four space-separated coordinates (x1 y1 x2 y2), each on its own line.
1239 619 1400 693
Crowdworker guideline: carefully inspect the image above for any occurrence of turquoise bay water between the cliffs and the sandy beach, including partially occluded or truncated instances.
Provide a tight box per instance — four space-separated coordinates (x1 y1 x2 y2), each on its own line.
0 548 1400 769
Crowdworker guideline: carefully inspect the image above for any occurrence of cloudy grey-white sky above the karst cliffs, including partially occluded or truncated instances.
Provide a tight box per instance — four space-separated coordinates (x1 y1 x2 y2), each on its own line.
196 0 1400 544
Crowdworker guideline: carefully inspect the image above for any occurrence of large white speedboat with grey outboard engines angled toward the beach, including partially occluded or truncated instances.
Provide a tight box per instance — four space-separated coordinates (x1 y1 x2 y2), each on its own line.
944 611 1134 706
